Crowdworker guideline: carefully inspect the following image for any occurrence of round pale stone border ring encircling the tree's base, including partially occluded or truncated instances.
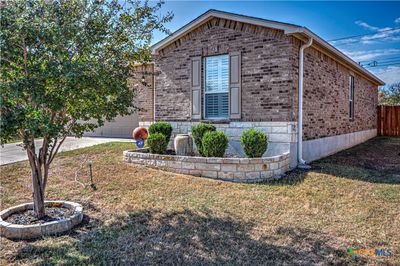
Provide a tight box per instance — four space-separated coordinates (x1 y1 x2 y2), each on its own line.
0 201 83 239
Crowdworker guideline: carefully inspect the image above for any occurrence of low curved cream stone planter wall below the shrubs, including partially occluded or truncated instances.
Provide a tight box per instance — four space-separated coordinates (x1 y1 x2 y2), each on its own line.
124 149 289 183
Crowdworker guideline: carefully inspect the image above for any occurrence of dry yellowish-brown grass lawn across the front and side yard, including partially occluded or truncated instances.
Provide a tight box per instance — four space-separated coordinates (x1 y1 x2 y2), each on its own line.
0 138 400 265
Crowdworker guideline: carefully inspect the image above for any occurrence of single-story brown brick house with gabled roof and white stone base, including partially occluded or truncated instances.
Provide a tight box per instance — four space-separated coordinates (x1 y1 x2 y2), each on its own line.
138 10 384 167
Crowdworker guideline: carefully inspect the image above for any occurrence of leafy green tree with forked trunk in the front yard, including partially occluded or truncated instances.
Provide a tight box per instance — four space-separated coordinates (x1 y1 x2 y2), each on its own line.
0 0 172 218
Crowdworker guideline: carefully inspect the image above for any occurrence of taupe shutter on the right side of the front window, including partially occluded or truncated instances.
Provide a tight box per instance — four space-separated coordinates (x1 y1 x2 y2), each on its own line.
229 52 242 119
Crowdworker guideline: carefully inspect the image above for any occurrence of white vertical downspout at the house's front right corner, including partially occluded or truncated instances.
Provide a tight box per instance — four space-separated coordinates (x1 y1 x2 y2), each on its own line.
297 37 313 168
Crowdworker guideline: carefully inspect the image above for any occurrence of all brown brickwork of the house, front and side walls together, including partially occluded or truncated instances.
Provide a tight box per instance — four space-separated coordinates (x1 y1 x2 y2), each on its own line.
138 18 377 140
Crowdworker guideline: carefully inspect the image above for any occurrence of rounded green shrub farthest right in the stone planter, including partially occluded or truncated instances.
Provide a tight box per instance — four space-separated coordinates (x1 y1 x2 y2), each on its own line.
240 128 268 158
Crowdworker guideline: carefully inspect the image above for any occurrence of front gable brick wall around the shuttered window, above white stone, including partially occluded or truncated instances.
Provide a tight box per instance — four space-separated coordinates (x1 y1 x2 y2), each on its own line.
155 18 293 121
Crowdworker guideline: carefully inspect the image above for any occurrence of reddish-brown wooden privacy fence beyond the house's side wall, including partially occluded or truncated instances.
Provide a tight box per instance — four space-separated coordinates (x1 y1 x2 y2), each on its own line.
377 105 400 136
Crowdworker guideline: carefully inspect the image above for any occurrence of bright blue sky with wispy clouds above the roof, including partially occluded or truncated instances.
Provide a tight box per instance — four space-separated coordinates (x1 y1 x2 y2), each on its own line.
153 0 400 84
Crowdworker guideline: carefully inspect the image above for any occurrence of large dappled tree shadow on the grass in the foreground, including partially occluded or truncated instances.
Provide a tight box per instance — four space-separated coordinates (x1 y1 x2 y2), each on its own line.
13 210 362 265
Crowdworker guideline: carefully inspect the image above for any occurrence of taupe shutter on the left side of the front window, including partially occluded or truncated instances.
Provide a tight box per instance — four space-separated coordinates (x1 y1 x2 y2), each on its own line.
190 56 201 119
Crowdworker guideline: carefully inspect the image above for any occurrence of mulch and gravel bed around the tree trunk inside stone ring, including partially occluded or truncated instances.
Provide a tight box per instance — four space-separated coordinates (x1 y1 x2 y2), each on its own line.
5 207 74 225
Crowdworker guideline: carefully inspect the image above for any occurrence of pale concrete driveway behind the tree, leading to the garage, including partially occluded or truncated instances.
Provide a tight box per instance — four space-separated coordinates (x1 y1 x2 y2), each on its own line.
0 137 133 165
